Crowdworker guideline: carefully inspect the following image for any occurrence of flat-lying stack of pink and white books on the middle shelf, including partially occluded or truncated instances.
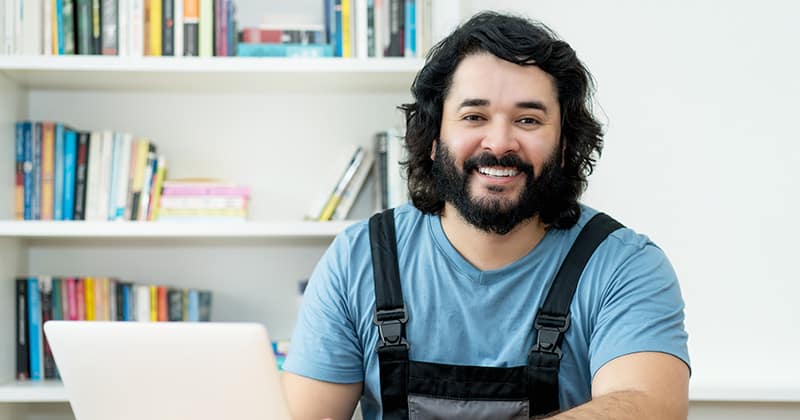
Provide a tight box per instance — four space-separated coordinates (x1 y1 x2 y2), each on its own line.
156 179 250 222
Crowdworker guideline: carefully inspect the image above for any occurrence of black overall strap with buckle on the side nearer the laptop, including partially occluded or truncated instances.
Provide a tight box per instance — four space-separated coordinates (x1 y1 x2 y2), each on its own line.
369 209 408 420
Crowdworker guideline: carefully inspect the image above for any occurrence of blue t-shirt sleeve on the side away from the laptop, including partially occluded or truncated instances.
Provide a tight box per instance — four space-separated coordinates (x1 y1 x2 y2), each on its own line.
589 243 689 377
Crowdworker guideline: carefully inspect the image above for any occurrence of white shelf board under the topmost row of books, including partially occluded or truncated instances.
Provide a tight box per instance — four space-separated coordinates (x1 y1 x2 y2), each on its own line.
0 55 423 93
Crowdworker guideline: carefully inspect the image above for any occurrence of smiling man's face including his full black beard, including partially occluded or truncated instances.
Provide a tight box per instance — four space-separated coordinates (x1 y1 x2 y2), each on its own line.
431 54 561 234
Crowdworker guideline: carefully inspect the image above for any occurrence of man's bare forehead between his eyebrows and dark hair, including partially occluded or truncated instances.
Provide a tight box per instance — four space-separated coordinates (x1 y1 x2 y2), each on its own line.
445 53 558 109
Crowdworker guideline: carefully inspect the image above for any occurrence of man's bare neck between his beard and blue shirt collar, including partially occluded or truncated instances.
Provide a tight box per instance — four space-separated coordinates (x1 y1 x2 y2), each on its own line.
441 203 547 270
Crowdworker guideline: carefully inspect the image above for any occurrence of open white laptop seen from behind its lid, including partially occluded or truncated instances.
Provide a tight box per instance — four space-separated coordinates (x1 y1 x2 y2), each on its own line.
44 321 290 420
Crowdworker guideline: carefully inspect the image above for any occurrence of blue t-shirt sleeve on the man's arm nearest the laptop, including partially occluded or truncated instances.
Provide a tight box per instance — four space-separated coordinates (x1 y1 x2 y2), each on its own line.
283 234 364 383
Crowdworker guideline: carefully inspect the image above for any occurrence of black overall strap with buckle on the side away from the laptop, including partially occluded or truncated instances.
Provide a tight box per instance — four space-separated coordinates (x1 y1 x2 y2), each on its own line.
528 213 623 416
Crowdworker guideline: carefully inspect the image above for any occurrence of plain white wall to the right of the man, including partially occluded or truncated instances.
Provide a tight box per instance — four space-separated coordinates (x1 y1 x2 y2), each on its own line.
470 0 800 410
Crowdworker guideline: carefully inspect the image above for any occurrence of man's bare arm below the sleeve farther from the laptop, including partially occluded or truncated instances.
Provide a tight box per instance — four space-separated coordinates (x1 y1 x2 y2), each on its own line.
551 352 689 420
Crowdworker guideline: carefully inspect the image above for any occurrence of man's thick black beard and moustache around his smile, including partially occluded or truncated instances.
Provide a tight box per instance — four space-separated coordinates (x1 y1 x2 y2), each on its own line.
432 139 566 235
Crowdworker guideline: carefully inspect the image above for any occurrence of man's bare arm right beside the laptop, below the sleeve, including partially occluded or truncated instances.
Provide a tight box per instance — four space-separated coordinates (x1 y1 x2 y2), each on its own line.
281 371 363 420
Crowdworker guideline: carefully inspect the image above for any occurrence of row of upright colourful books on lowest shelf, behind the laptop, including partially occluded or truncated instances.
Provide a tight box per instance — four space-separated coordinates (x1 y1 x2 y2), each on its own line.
14 275 211 380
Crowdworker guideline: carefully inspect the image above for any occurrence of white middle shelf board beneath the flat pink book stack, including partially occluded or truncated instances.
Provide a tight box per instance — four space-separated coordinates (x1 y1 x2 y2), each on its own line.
0 220 354 239
